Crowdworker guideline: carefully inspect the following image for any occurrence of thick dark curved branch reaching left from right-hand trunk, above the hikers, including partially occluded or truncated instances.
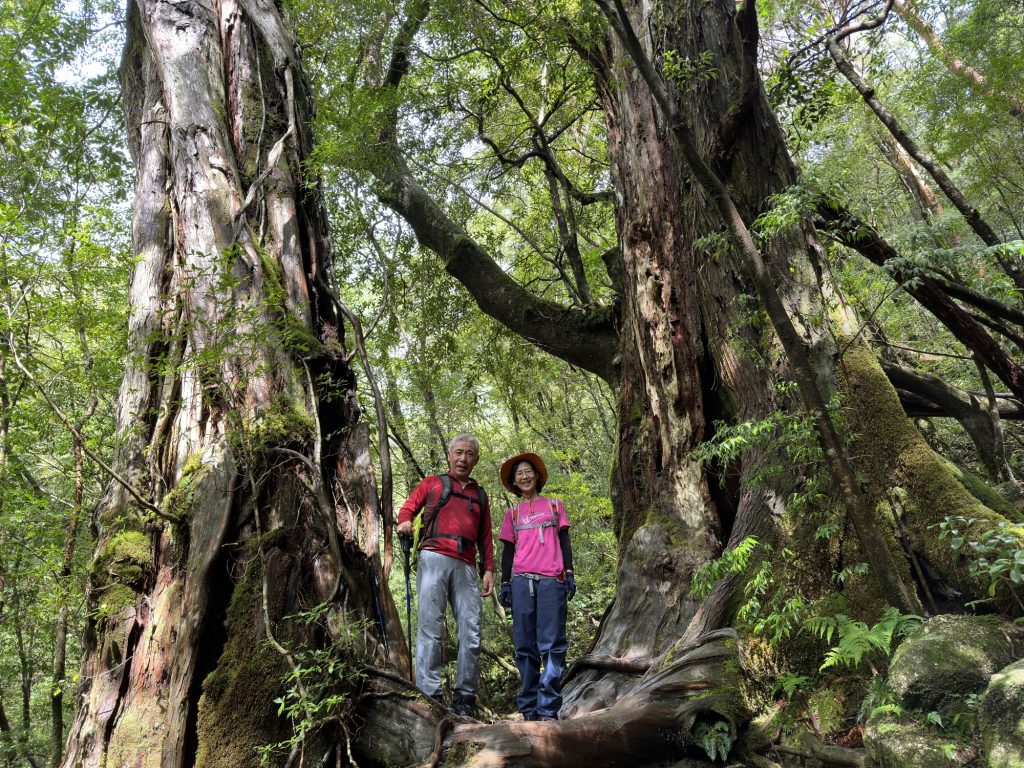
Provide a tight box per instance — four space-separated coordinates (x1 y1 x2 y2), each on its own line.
374 140 617 383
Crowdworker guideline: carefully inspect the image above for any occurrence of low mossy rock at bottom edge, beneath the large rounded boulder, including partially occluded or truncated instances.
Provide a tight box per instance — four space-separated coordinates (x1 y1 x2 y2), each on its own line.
864 717 974 768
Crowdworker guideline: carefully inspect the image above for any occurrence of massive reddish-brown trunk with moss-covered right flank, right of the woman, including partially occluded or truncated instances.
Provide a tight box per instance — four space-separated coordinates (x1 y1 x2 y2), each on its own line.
563 0 1007 729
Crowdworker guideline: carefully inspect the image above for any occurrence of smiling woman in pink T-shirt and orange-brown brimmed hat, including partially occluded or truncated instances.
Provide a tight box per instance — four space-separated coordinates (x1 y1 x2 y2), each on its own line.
499 453 575 720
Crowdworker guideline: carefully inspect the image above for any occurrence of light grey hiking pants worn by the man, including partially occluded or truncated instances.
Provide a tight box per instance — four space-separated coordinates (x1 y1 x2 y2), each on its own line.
416 550 481 696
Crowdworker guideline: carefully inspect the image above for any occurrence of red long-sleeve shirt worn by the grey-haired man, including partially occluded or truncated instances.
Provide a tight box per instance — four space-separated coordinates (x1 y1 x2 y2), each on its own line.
398 474 495 570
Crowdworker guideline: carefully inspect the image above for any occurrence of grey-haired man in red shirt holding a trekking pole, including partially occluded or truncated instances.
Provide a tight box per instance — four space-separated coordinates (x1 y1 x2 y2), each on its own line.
398 433 495 716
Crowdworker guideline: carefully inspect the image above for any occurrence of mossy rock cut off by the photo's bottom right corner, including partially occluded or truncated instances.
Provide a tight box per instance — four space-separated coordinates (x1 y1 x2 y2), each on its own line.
978 660 1024 768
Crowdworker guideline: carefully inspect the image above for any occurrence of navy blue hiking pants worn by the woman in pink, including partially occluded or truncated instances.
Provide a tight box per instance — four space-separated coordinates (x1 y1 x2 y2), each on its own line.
512 573 569 720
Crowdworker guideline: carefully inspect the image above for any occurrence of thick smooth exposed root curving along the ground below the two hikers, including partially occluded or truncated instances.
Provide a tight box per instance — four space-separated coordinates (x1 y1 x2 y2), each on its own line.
359 631 743 768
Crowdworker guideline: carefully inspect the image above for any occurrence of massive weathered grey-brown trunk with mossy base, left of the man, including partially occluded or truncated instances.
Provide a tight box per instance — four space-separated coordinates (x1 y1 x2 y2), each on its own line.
63 0 408 768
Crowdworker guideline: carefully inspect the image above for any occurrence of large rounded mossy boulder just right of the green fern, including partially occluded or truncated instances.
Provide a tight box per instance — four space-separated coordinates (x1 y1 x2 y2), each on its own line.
889 615 1024 712
